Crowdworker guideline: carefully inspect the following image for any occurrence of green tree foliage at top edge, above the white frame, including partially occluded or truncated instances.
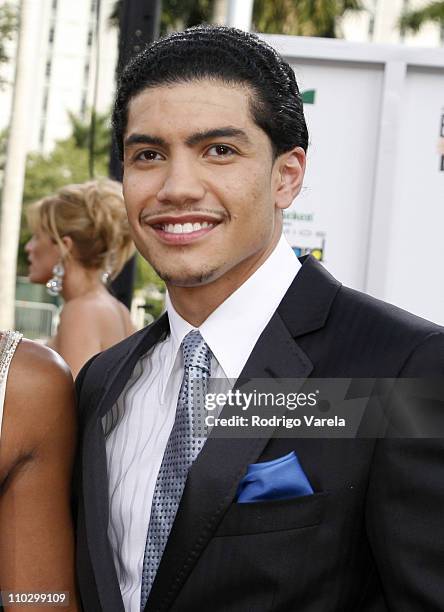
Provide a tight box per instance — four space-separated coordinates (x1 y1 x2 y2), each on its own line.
253 0 364 38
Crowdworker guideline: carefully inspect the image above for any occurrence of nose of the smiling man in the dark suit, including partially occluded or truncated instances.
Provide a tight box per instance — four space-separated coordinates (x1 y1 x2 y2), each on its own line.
157 156 205 206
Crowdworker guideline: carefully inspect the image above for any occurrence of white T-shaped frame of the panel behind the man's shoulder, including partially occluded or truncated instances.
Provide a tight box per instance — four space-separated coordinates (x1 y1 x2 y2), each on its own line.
261 35 444 295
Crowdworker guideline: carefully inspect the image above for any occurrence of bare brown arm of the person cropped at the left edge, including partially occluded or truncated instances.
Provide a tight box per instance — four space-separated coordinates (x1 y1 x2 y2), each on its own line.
0 340 79 612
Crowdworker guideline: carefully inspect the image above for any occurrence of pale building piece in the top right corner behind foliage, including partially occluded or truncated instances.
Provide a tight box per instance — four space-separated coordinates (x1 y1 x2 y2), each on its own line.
342 0 444 47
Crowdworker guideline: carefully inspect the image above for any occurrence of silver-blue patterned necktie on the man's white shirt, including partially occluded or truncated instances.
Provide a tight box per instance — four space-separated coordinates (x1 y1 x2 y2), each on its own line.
140 330 211 610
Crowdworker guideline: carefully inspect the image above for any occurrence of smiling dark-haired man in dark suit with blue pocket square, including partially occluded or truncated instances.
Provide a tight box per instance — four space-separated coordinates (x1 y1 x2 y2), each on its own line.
76 27 444 612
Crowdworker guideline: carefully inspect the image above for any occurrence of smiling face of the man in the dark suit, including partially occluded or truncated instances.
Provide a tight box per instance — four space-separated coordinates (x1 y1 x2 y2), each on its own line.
123 80 305 294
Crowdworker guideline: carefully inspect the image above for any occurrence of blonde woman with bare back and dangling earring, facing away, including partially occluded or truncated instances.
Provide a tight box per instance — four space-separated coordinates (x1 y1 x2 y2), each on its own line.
25 179 134 377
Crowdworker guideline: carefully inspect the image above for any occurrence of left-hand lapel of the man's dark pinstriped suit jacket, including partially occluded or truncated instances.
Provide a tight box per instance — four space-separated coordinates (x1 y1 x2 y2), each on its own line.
82 316 169 612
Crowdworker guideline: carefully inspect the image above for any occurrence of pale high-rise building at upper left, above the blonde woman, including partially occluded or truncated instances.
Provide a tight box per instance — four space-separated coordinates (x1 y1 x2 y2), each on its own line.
0 0 118 153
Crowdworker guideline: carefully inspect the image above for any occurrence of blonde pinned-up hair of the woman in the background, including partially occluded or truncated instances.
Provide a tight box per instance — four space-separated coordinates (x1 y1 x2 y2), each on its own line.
27 179 134 278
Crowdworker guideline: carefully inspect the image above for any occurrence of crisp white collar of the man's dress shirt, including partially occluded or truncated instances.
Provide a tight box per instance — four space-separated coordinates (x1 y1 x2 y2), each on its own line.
166 235 301 380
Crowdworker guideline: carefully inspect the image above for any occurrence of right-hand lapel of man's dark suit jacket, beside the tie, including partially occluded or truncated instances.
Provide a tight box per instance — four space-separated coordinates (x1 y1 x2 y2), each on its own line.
145 256 340 612
